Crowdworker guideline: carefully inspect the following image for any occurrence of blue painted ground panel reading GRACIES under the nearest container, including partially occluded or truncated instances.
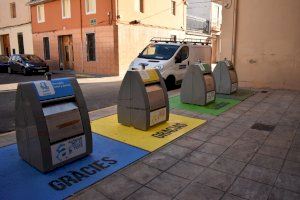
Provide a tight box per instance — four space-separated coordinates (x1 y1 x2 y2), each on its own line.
0 134 149 199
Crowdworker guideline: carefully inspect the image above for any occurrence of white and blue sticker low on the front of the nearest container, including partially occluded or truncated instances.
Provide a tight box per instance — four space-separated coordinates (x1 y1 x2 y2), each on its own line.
51 135 86 165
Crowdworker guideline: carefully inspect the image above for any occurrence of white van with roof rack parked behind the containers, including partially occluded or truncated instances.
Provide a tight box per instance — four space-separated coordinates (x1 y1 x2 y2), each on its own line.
129 38 212 88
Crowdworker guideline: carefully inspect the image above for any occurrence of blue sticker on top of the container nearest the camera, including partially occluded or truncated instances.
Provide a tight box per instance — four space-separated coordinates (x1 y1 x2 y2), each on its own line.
32 78 74 101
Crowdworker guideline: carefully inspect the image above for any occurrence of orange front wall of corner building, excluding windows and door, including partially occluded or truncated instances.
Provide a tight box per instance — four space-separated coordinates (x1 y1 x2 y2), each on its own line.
31 0 119 75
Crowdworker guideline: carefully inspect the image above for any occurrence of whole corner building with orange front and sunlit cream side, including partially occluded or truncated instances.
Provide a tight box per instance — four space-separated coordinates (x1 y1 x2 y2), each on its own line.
30 0 195 75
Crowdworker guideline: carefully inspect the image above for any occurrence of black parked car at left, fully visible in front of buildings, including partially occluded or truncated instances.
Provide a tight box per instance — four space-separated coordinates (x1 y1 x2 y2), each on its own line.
7 54 49 75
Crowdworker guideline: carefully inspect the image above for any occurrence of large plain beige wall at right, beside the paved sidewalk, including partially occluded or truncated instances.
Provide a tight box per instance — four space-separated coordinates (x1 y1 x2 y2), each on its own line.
221 0 300 90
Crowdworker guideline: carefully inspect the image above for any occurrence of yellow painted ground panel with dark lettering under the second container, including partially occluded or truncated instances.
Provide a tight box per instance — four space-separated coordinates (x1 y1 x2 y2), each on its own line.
91 114 206 151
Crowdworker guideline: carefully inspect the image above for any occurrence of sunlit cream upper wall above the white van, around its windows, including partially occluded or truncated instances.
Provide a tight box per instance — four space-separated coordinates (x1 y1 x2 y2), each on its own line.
117 0 186 29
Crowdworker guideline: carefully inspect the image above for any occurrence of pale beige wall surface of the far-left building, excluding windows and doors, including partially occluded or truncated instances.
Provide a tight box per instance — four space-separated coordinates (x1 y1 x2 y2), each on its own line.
0 0 33 54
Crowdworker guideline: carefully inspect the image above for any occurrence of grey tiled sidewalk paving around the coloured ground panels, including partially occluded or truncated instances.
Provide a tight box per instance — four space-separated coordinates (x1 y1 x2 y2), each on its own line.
0 90 300 200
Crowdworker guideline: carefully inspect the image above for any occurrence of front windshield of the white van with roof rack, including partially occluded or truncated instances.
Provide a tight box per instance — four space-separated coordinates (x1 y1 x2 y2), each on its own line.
138 44 179 60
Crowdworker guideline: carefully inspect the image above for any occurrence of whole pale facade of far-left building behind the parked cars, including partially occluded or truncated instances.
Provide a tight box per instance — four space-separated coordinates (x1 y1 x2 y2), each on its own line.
0 0 33 56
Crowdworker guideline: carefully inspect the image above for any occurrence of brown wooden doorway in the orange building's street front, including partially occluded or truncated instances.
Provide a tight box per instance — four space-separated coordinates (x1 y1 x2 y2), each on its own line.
58 35 74 70
